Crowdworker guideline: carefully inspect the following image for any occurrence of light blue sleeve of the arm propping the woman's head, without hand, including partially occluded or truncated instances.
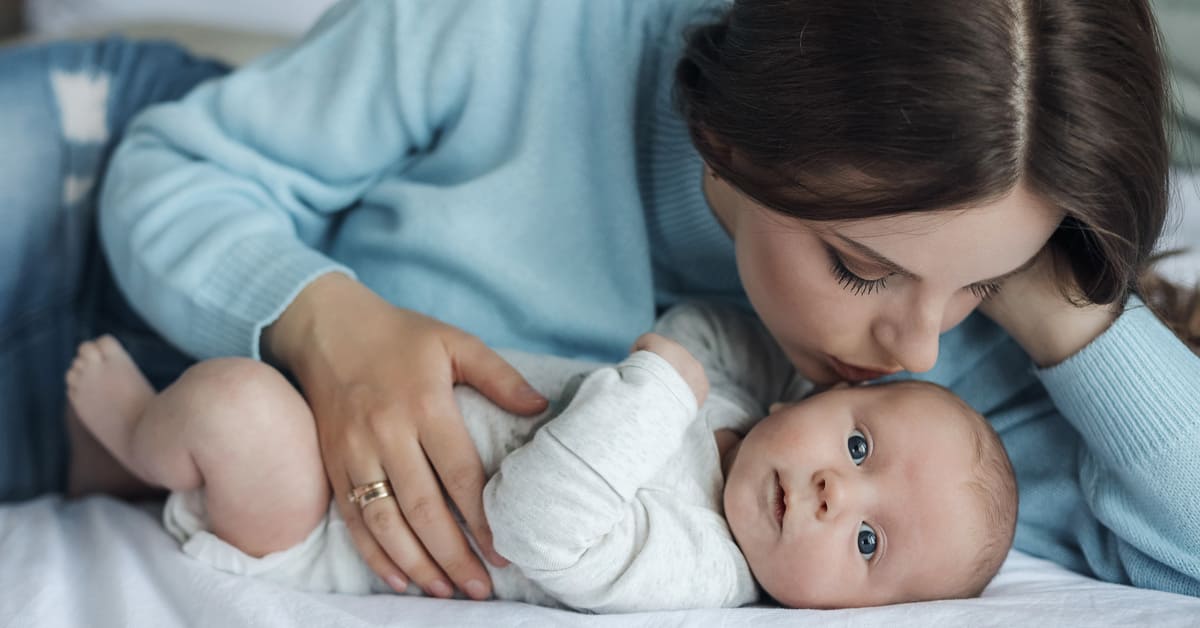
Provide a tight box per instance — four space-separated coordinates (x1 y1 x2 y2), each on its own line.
1038 299 1200 596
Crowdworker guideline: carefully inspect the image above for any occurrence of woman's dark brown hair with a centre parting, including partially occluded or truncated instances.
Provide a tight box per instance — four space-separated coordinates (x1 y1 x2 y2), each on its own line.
676 0 1169 304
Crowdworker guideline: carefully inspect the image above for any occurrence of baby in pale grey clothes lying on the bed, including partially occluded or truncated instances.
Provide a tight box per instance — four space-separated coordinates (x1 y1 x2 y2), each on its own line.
67 305 1016 612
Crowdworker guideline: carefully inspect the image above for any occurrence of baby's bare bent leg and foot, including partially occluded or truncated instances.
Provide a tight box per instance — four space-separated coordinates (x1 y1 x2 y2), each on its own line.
67 336 329 556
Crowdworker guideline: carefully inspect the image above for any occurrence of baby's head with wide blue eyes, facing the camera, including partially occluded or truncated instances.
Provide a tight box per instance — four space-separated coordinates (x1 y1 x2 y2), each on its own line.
725 382 1016 608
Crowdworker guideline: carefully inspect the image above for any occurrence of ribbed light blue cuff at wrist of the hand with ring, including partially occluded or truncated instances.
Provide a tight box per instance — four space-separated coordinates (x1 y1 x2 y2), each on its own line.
191 234 354 359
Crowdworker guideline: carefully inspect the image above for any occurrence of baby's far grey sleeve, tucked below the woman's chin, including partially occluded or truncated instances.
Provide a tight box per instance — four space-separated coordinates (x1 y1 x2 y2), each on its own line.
654 301 812 433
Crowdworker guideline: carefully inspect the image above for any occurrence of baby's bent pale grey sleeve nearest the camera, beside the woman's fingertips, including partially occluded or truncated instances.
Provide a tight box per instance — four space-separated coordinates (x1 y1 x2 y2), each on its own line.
484 352 752 612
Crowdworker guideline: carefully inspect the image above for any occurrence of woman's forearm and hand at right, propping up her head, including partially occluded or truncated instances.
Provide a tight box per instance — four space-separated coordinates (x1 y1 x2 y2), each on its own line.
984 247 1200 596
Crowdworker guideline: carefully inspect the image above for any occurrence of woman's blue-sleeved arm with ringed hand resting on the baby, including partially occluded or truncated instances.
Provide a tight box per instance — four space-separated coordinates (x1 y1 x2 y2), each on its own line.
101 0 544 597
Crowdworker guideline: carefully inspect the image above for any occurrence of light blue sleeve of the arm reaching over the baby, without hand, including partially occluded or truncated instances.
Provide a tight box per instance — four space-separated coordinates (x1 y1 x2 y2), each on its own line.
100 0 536 358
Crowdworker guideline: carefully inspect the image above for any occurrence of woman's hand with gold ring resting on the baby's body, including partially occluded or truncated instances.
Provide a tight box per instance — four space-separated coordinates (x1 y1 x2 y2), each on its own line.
263 274 546 599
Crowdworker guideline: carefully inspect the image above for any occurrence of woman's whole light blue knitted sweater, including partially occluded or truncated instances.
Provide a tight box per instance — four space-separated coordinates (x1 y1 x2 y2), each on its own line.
101 0 1200 594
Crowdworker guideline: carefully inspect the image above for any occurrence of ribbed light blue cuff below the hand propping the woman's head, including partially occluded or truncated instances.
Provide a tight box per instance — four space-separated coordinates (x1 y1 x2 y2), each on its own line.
1038 298 1200 465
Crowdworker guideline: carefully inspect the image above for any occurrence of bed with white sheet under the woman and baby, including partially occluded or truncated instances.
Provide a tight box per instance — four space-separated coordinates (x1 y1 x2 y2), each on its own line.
7 6 1200 628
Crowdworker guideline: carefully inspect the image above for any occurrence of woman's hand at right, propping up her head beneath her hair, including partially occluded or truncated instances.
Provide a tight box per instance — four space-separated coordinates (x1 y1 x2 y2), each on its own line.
979 246 1123 367
